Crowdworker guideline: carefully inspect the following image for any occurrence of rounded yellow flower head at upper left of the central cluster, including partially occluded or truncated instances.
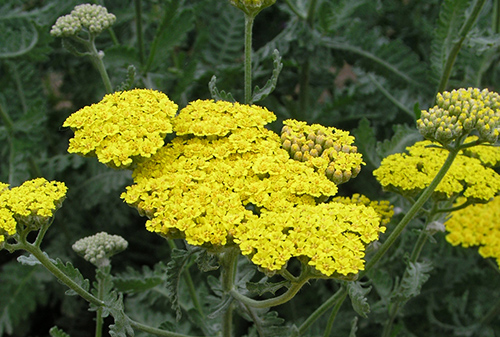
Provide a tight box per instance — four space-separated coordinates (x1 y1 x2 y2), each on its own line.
63 89 177 168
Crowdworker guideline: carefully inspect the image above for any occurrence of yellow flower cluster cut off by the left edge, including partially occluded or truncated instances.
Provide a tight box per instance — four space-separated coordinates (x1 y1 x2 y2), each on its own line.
0 178 67 243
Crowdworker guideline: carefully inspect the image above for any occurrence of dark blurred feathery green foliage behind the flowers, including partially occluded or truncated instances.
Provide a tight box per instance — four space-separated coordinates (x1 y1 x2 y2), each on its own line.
0 0 500 337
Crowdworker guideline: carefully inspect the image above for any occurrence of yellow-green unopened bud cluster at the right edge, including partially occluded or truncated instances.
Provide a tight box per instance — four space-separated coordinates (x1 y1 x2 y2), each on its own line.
417 88 500 144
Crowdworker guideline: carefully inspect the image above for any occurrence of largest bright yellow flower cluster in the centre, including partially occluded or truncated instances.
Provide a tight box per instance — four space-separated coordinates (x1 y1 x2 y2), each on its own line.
122 100 384 276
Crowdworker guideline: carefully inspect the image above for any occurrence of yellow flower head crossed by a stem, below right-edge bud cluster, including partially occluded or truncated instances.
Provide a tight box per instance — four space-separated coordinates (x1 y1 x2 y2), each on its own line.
373 141 500 202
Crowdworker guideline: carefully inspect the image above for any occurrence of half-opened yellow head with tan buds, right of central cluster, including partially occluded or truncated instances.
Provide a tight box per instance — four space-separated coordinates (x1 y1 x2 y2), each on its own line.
281 120 364 184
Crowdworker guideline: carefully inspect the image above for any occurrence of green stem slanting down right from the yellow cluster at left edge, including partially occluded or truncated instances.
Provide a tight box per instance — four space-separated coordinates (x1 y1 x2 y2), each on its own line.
21 242 105 307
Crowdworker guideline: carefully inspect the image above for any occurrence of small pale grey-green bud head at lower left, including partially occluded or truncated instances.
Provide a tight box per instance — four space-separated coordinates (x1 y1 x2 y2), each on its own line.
72 232 128 267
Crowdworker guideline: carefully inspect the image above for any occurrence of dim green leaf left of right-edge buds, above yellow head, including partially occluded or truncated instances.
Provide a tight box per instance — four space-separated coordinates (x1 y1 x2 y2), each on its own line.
376 125 423 158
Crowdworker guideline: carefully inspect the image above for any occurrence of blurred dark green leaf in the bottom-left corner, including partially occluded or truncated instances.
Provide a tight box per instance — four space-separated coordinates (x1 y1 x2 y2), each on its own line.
0 261 47 336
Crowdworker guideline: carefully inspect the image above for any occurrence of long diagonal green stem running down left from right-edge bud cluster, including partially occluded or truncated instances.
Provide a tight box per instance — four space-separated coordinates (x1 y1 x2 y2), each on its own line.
359 146 461 279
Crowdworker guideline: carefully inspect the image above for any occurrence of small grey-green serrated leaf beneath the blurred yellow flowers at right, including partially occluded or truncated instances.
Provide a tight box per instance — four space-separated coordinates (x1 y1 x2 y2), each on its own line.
393 261 434 300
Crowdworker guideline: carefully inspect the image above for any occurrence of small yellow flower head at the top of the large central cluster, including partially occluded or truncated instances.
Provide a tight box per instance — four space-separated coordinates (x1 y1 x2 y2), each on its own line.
174 100 276 137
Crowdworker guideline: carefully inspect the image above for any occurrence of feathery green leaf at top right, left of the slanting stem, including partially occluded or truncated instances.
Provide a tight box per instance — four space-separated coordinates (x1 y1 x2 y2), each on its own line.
430 0 471 83
